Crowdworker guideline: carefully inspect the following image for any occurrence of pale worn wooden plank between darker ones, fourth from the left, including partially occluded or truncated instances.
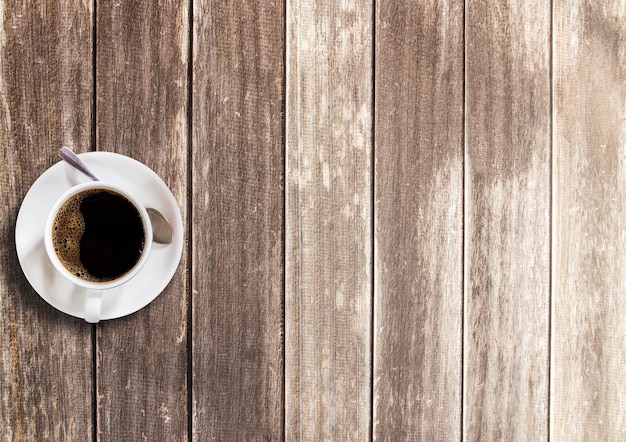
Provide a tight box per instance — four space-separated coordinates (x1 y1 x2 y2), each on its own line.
285 0 373 440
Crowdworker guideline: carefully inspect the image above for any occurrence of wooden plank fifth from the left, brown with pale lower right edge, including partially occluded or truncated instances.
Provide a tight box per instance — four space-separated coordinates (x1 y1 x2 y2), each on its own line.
374 0 463 441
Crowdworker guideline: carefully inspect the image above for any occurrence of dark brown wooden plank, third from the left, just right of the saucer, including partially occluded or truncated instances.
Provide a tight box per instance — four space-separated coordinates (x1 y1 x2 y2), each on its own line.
192 0 284 441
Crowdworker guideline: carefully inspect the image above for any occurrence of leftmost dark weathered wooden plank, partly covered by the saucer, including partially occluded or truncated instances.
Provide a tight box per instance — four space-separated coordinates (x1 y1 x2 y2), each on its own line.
0 0 93 441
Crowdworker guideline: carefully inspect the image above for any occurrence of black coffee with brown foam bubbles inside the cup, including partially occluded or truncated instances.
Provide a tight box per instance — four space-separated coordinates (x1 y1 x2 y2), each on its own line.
52 189 145 282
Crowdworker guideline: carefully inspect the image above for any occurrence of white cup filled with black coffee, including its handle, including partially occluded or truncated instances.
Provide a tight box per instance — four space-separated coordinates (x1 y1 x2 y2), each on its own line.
44 181 152 322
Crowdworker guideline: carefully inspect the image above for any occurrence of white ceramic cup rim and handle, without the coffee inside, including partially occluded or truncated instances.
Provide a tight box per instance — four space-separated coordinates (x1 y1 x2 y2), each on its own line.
44 181 152 323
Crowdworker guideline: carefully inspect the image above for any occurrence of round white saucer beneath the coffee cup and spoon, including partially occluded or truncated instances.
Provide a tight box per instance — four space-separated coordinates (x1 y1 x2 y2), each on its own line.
15 152 184 319
